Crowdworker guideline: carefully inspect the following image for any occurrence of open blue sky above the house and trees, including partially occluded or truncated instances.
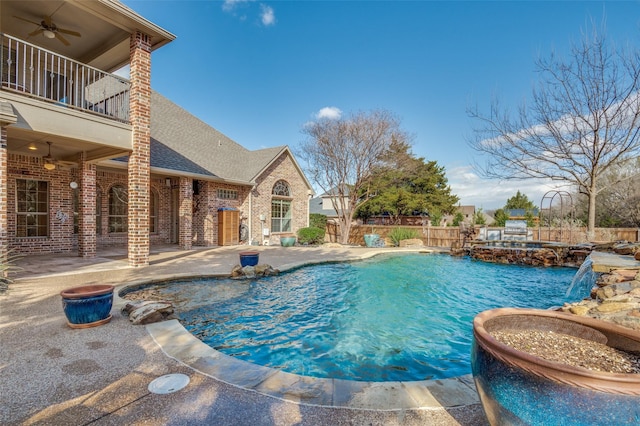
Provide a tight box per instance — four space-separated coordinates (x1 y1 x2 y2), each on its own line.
124 0 640 210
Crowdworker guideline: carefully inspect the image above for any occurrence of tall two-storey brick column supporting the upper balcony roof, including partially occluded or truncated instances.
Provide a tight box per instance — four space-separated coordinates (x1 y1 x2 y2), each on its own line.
128 31 151 266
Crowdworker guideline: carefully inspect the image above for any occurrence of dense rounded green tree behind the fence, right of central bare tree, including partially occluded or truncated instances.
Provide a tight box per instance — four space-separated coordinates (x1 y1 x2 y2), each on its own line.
356 140 459 224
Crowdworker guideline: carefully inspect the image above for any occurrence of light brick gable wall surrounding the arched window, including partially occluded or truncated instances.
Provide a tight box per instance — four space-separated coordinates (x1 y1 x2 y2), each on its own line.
250 153 309 244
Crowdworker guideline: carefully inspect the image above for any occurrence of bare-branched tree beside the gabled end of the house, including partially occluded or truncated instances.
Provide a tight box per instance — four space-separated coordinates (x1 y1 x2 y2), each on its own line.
297 110 407 244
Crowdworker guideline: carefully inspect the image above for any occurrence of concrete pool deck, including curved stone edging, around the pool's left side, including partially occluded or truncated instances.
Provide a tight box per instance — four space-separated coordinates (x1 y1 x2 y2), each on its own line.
0 246 487 426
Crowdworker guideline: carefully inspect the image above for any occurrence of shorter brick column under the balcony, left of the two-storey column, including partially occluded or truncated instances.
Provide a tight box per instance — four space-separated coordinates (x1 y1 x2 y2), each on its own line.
78 153 96 258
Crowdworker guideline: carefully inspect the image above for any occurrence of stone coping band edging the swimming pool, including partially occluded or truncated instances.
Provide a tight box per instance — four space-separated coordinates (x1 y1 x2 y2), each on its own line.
114 247 480 411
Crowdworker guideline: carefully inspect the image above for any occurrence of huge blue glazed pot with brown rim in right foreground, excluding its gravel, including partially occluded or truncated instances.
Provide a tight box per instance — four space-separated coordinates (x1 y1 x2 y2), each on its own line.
471 308 640 425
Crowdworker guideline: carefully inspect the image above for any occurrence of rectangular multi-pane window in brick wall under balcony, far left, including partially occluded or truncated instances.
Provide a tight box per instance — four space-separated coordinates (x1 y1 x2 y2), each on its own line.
16 179 49 237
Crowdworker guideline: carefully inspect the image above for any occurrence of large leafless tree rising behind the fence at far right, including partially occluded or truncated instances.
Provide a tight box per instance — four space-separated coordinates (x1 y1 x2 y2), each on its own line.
469 25 640 238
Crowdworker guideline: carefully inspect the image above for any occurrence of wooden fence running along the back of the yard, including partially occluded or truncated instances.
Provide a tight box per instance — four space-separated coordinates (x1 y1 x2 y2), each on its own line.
325 223 640 247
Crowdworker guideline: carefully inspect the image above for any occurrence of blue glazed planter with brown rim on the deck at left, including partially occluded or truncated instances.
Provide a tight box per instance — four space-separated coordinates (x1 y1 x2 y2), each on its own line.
60 284 113 328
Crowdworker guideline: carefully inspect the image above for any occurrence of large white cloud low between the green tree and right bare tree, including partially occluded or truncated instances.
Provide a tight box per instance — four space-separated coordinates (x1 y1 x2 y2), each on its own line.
447 166 571 210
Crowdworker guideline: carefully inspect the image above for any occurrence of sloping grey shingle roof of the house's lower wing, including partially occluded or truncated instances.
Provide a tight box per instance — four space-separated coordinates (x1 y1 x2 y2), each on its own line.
110 92 311 190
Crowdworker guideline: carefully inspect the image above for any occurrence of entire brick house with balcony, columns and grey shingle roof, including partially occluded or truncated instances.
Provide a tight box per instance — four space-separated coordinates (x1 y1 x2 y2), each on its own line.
0 0 313 266
